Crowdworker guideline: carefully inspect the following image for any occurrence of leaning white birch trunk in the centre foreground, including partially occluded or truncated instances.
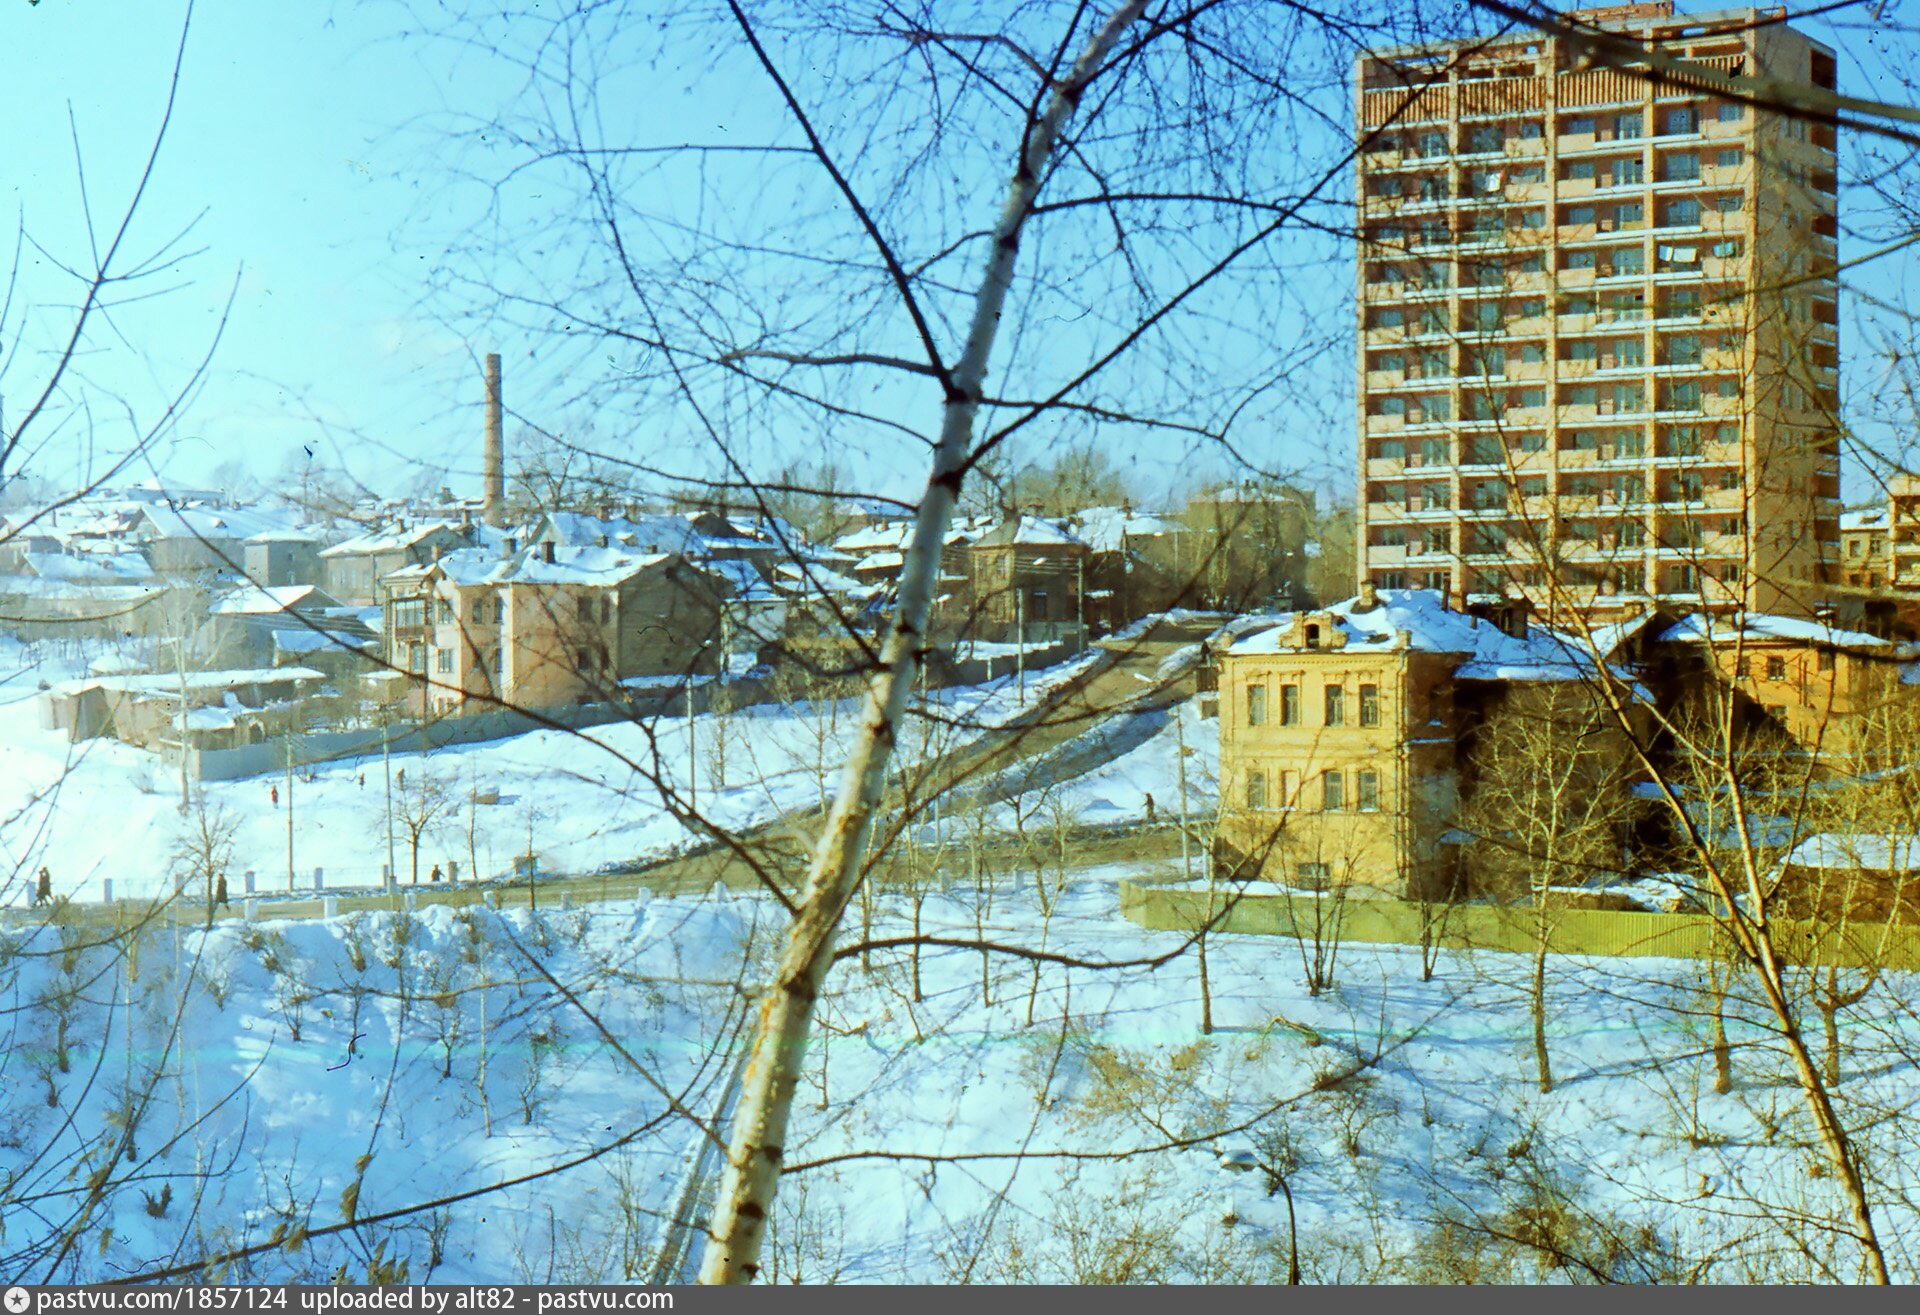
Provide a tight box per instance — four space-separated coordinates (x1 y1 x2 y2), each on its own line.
701 0 1146 1282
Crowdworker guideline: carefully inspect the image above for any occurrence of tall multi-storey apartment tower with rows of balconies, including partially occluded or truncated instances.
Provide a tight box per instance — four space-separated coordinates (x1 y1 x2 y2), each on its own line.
1356 4 1839 620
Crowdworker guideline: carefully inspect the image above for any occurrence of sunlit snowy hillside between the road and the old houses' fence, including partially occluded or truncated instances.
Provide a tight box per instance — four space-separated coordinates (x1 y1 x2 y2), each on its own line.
0 641 1113 902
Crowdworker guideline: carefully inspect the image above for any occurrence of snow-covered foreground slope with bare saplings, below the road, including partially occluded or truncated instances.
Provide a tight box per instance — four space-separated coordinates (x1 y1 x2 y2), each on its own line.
0 873 1920 1282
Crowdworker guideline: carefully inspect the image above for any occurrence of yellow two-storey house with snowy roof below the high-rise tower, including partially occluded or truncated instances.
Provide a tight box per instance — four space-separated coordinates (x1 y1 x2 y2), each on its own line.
1215 589 1635 897
